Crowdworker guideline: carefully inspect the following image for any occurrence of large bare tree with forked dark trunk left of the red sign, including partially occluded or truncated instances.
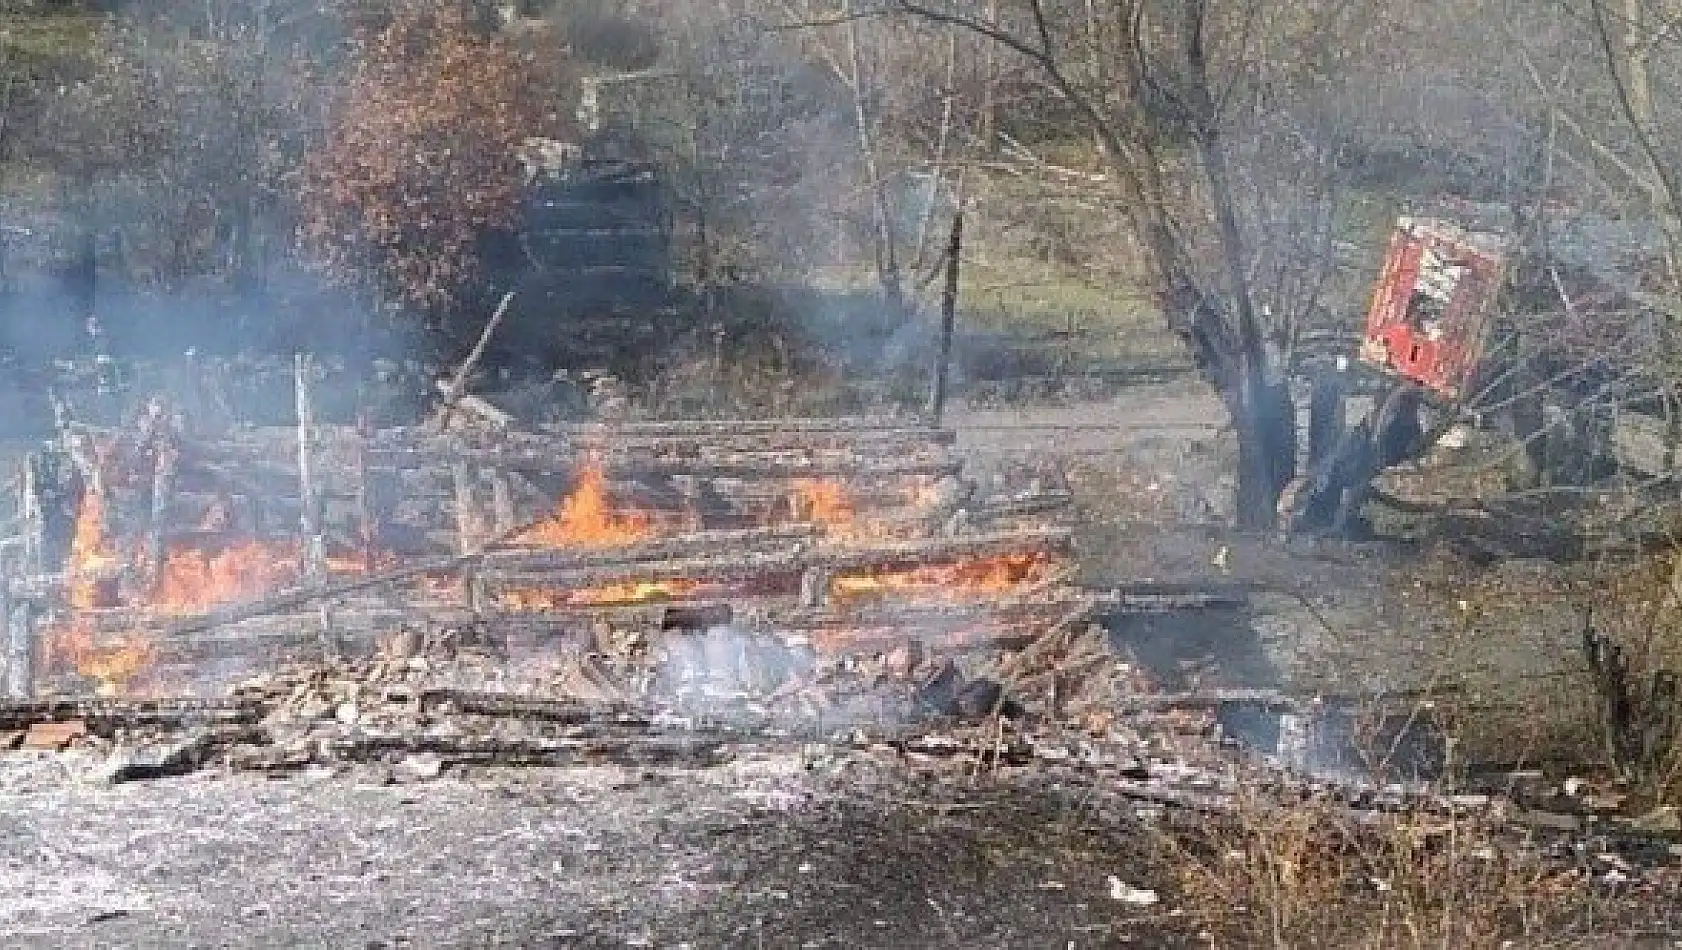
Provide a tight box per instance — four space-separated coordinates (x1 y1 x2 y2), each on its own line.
883 0 1347 528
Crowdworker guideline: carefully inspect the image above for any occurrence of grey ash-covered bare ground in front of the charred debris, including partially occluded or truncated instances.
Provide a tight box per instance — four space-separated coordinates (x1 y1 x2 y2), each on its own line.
0 750 1172 948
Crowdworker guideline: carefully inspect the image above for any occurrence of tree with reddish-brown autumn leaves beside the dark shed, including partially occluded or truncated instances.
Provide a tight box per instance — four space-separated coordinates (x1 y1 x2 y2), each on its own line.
299 0 565 313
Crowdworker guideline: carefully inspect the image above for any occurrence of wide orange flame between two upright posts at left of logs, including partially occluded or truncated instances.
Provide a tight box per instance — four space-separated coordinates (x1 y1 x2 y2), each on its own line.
145 540 298 615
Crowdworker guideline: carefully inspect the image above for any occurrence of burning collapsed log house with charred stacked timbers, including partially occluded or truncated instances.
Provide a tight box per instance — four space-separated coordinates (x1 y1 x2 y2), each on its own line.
0 362 1174 696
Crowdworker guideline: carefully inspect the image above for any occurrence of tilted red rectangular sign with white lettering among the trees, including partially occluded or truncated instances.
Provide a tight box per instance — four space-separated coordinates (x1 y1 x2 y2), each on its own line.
1361 219 1505 400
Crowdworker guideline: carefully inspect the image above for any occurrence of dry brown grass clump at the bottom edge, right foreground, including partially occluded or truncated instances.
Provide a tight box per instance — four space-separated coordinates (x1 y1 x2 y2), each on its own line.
1172 799 1608 950
